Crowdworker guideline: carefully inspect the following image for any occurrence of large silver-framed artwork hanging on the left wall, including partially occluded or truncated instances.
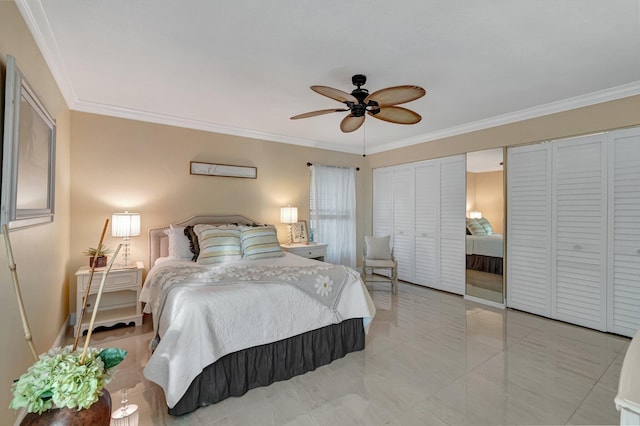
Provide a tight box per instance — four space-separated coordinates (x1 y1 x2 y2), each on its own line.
0 56 56 229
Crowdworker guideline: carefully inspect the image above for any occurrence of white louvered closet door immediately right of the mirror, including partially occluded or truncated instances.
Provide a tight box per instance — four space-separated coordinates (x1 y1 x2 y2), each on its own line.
506 144 551 316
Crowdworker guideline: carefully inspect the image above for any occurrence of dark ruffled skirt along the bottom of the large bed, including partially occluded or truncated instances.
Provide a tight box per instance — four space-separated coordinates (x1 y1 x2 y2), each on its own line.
169 318 365 416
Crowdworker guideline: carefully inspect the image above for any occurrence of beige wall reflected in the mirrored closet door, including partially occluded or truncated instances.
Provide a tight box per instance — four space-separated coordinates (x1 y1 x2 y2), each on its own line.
467 170 504 234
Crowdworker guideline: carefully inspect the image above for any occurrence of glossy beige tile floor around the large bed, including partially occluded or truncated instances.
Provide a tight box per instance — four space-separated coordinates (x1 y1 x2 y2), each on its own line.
75 283 629 426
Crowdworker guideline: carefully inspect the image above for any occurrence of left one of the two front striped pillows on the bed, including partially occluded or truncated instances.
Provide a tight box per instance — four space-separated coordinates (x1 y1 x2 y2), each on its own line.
193 225 242 265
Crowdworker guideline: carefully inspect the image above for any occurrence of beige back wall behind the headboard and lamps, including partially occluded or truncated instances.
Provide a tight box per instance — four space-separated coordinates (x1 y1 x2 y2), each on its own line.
69 112 370 306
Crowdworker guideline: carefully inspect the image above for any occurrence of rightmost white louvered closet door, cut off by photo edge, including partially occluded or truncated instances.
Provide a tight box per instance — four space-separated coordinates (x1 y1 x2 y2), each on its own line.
607 128 640 337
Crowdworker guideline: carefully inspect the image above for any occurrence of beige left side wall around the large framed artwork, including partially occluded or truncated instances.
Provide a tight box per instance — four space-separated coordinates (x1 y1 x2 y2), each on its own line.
0 1 70 425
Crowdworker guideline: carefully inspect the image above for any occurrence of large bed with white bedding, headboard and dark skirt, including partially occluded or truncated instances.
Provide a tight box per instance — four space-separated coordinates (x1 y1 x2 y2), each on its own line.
140 215 375 415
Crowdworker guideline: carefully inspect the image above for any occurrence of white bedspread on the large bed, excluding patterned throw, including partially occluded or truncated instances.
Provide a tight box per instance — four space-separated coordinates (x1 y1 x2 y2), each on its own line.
140 253 375 407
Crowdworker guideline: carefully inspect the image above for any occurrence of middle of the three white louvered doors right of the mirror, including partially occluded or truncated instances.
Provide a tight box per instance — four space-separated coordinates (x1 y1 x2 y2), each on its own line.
551 134 607 330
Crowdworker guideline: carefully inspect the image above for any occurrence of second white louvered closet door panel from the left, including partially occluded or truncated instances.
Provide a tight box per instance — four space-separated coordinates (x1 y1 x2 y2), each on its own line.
391 166 414 282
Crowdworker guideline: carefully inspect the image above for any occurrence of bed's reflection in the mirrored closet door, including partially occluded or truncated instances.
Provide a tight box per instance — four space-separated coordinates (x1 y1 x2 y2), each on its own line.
466 218 504 275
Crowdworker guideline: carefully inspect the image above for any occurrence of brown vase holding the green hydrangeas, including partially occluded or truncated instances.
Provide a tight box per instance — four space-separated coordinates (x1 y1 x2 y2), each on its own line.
20 389 111 426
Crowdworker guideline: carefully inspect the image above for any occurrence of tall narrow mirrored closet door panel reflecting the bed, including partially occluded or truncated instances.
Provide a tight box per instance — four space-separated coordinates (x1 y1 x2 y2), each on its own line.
465 148 504 305
